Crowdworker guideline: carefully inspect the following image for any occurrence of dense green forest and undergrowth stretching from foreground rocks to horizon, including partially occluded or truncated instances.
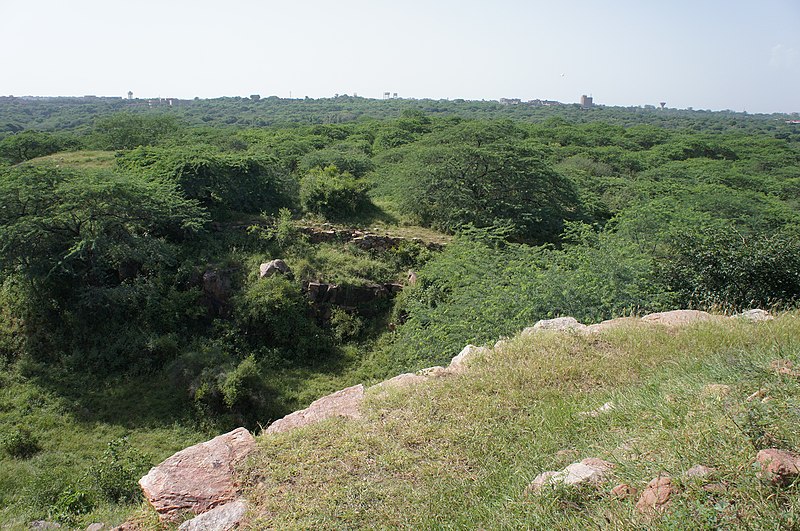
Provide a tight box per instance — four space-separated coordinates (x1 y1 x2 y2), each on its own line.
0 96 800 523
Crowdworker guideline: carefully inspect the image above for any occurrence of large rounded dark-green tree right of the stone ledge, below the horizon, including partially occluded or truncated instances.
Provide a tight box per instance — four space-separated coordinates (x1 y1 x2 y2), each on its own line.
391 122 577 242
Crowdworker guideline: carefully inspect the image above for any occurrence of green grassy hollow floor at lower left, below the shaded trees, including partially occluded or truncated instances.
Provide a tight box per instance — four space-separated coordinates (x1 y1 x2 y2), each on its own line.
0 362 216 530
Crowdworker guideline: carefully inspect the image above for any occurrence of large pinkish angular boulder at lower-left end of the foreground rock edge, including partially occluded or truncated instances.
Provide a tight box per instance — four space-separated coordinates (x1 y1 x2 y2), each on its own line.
139 428 256 520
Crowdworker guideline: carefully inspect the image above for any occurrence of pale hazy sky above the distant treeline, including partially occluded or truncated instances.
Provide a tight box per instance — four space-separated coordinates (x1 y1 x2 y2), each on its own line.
0 0 800 112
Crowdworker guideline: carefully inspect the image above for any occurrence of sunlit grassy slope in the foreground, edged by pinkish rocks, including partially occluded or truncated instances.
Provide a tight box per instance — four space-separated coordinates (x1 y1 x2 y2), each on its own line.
245 314 800 529
